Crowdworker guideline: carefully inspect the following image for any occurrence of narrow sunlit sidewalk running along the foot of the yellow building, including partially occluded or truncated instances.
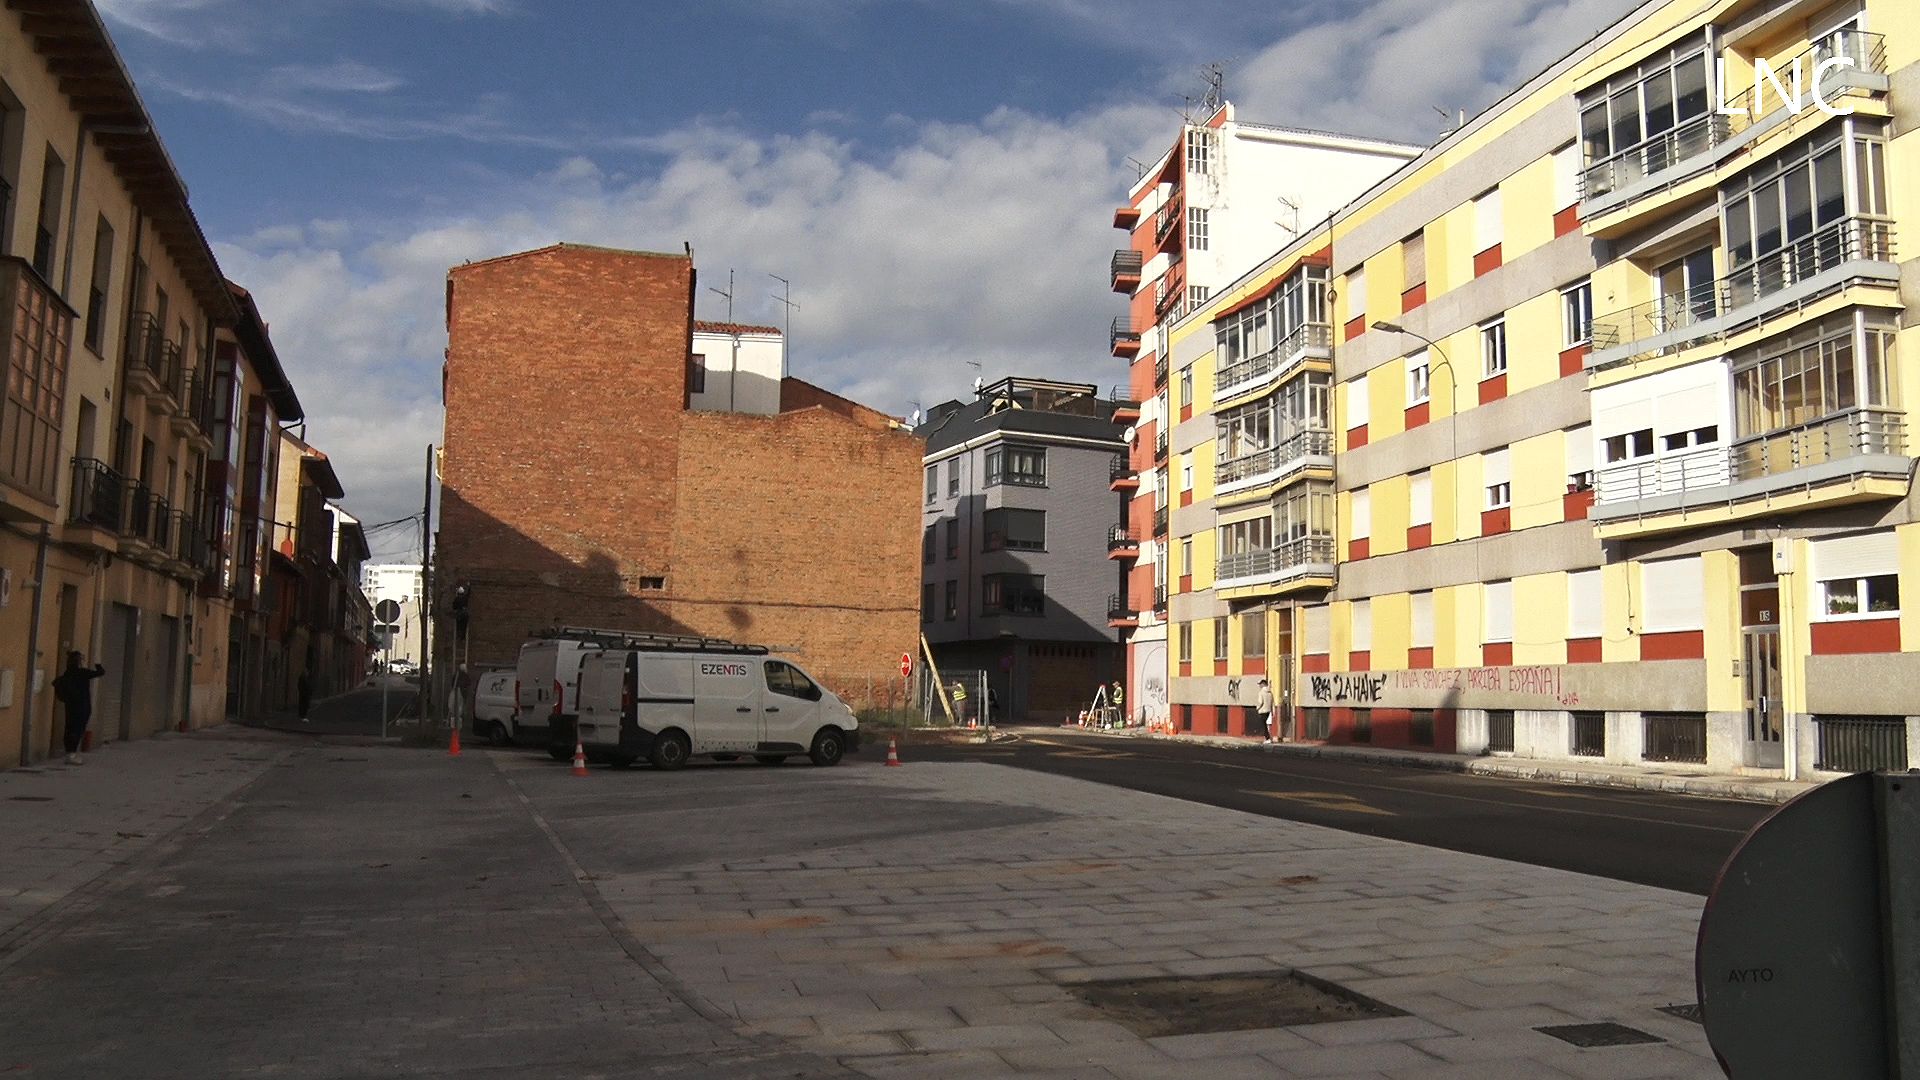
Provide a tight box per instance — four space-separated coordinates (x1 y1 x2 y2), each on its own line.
1052 726 1820 803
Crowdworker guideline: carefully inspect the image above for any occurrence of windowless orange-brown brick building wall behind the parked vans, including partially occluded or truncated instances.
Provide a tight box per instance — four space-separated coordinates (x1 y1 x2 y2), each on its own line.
432 244 922 703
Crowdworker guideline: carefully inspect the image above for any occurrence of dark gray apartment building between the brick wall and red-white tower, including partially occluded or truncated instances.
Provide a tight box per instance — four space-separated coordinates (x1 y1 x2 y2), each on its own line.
914 379 1125 721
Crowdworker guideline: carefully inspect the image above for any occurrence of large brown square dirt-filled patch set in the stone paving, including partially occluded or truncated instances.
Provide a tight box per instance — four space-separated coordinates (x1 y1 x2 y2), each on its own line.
1068 970 1405 1038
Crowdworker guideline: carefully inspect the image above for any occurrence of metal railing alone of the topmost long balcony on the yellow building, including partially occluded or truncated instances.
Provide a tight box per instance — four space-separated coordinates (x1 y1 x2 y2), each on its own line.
1580 29 1887 200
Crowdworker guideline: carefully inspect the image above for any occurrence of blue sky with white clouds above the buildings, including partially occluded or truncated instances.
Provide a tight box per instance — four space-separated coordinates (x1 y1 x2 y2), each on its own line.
86 0 1628 557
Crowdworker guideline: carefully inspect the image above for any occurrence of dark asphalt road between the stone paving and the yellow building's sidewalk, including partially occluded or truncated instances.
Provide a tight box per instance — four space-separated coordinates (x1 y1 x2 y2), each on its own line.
912 728 1772 896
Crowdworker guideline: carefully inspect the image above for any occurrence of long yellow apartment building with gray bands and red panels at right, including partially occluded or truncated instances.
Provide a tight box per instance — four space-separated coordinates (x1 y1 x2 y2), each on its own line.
1169 0 1920 776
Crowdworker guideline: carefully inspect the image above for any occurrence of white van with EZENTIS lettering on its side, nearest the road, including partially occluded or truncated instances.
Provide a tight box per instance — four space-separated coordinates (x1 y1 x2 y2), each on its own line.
576 646 860 769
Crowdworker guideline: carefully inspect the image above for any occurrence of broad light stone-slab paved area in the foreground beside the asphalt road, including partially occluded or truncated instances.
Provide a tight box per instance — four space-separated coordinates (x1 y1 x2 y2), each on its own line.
495 757 1720 1080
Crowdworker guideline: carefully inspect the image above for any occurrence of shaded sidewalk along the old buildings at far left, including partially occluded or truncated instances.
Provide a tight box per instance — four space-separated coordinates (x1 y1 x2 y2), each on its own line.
0 726 288 949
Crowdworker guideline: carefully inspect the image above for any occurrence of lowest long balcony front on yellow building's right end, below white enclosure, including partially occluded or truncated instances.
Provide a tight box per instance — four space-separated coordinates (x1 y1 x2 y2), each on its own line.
1592 407 1912 536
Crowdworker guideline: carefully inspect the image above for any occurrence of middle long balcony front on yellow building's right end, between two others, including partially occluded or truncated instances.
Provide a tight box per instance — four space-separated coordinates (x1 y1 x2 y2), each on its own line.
1588 217 1901 367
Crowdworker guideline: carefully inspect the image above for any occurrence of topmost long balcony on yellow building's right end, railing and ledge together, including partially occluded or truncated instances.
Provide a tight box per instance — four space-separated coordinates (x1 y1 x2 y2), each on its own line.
1578 27 1889 221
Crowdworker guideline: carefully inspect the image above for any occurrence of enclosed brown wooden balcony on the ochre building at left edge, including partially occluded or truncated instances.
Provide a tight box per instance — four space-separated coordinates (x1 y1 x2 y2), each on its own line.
0 258 75 525
